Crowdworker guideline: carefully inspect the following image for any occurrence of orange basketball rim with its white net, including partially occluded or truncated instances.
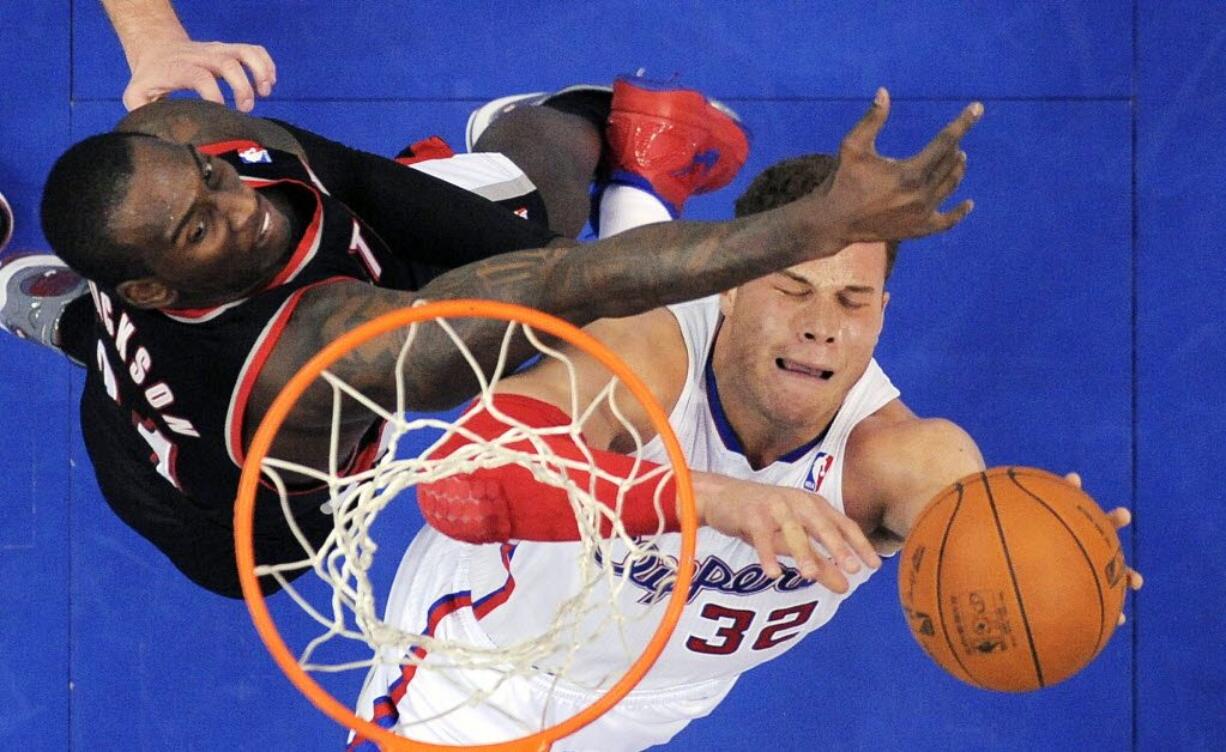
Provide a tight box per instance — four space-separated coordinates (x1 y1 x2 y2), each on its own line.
234 299 698 752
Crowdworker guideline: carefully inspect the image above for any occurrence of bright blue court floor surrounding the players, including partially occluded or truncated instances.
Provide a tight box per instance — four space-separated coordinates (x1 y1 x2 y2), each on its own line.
0 0 1226 751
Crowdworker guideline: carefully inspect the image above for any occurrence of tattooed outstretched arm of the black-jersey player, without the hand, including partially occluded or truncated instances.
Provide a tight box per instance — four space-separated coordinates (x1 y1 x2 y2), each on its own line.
256 223 794 467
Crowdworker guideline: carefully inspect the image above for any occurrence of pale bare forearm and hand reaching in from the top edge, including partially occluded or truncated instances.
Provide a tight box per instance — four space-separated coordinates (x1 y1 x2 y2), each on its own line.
102 0 277 112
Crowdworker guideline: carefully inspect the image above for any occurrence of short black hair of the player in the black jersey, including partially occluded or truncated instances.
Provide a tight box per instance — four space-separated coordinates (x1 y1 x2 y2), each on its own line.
40 132 153 287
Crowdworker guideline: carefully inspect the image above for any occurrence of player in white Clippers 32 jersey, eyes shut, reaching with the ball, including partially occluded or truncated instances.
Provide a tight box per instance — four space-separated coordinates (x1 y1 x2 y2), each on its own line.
354 149 1127 752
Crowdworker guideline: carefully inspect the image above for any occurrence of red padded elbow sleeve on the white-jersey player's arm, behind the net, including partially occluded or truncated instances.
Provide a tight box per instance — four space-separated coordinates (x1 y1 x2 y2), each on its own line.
417 394 680 543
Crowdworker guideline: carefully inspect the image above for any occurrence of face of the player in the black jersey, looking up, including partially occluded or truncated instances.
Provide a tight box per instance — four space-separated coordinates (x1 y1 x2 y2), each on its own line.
109 140 291 307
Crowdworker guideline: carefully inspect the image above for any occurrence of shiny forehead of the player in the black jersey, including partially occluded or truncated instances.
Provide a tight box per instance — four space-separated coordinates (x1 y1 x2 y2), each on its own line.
110 139 200 243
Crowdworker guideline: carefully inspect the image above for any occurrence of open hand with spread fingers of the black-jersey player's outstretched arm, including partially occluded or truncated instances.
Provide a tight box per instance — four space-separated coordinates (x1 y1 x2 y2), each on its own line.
818 88 983 244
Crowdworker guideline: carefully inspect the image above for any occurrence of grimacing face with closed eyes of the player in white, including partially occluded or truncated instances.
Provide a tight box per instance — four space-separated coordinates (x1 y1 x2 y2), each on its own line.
716 243 889 438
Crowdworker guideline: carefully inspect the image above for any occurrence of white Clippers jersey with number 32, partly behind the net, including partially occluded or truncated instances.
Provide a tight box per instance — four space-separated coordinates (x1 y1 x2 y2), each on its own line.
359 297 899 750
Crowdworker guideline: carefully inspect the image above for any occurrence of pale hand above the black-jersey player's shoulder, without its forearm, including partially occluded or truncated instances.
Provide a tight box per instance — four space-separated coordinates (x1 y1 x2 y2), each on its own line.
124 39 277 112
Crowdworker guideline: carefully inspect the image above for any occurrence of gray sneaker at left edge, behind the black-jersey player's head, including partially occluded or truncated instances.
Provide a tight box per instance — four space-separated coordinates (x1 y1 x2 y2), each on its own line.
0 253 88 352
